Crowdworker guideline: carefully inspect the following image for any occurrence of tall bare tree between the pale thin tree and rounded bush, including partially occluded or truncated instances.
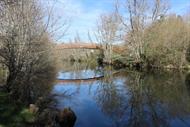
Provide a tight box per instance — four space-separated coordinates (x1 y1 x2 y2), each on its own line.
122 0 168 63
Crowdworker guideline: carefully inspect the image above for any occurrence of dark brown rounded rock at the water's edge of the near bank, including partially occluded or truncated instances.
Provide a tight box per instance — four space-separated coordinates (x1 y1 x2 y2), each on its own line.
59 108 77 127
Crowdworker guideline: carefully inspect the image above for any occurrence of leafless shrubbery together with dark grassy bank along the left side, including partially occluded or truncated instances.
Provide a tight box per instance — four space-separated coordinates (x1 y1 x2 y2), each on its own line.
0 0 76 127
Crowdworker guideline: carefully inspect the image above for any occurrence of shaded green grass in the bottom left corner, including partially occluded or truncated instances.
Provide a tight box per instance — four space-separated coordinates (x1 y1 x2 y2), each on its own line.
0 92 35 127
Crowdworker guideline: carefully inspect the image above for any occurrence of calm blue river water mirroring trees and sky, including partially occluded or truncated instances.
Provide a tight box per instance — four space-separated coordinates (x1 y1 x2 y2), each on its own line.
52 64 190 127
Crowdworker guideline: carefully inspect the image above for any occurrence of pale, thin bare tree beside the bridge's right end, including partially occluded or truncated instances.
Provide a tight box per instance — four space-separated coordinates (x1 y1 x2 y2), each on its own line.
95 4 121 64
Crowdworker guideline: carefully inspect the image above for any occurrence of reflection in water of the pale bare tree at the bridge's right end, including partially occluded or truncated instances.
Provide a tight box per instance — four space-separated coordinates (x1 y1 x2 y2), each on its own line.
95 68 129 126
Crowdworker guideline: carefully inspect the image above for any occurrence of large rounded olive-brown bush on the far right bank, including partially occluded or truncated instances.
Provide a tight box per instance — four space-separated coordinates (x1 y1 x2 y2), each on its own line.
144 15 190 68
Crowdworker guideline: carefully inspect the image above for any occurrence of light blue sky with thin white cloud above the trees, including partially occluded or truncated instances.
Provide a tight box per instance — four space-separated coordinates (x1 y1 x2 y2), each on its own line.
53 0 190 42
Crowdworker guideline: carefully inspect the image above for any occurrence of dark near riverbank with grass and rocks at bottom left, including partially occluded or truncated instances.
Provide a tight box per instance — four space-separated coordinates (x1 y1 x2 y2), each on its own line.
0 91 76 127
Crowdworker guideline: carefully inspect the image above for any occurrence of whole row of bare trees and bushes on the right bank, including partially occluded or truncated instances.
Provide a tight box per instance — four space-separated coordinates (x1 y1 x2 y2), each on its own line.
95 0 190 69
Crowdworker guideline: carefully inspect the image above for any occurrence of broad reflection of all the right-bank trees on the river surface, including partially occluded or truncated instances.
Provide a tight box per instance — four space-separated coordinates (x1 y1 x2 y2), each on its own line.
95 72 190 127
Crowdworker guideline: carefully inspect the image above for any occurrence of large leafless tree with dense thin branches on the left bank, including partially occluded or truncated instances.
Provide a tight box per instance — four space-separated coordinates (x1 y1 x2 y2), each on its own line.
0 0 67 92
